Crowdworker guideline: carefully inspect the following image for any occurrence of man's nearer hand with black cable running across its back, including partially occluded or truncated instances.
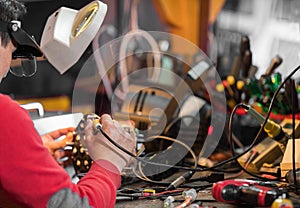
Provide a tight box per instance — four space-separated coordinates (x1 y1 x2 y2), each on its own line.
81 114 136 172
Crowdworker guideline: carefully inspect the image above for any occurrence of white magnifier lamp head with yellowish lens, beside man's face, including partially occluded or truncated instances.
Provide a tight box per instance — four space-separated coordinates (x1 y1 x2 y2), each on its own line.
40 1 107 74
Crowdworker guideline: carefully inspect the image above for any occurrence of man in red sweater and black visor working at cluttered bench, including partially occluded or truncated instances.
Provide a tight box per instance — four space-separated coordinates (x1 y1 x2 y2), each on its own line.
0 0 135 208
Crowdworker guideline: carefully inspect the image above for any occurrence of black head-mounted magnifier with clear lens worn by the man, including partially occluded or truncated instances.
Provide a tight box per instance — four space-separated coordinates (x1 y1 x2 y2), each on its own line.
0 20 43 77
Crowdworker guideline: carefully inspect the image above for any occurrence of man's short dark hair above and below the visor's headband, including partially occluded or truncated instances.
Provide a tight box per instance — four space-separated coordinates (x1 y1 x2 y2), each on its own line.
0 0 27 47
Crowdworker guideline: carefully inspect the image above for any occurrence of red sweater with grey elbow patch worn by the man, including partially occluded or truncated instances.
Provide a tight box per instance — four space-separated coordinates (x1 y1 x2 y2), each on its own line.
0 94 121 208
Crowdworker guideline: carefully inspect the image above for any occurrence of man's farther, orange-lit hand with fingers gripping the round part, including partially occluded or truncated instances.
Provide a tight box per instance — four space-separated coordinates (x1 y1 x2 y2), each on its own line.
41 127 75 165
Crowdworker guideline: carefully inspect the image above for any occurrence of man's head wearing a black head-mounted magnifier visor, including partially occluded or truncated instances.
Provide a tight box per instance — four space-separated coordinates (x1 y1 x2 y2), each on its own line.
0 0 43 79
